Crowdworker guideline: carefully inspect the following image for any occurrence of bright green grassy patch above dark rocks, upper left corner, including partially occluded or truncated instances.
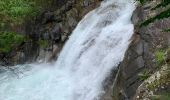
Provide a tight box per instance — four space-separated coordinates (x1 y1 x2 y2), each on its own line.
0 0 52 27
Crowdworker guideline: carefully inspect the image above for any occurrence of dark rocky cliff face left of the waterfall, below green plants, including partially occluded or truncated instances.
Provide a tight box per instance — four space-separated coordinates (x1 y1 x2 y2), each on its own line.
0 0 101 65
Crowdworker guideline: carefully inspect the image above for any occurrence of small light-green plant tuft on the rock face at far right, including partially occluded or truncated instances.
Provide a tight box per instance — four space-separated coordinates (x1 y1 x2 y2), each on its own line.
155 50 165 66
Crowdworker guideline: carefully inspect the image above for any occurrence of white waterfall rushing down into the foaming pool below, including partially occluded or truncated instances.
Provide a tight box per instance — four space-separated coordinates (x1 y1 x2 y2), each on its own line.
0 0 135 100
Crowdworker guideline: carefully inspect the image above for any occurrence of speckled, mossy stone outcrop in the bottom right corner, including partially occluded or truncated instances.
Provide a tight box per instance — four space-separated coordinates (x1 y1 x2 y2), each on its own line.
134 65 170 100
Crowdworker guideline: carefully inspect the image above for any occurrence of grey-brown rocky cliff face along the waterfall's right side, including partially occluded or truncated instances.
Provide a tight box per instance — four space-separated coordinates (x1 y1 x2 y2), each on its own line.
105 0 170 100
